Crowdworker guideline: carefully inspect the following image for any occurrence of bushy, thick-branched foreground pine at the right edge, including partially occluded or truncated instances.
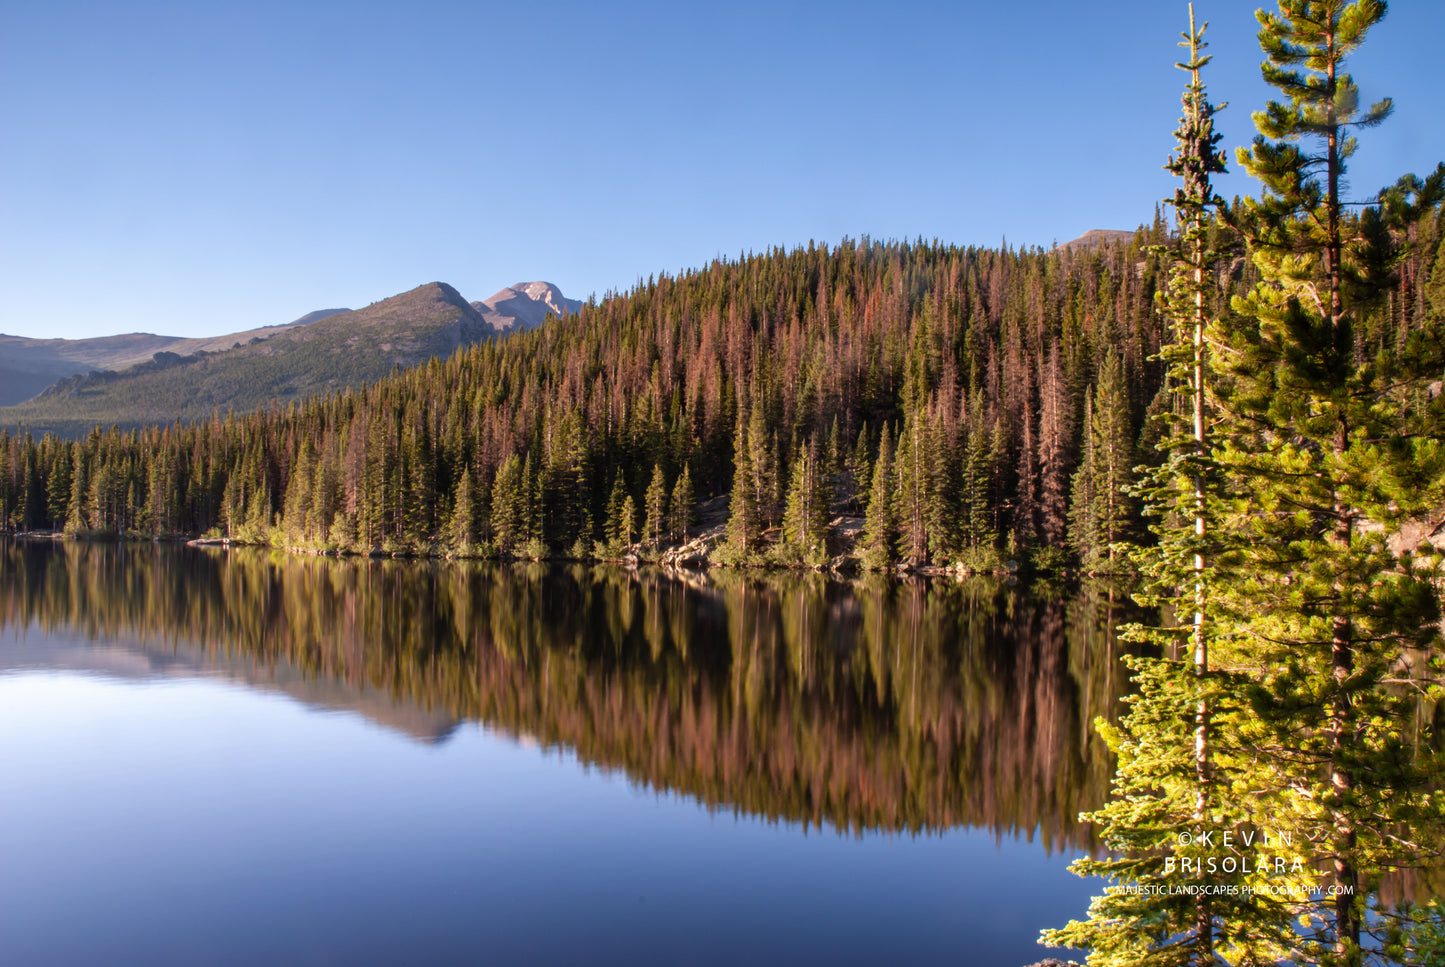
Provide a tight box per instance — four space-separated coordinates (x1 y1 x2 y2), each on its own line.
1212 0 1445 964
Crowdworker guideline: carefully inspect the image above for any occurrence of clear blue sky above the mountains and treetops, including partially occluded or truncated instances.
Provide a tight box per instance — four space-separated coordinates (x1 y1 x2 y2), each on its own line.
0 0 1445 337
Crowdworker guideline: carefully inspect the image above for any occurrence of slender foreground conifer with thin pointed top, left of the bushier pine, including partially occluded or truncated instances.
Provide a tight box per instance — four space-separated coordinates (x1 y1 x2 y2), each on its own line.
1042 13 1302 967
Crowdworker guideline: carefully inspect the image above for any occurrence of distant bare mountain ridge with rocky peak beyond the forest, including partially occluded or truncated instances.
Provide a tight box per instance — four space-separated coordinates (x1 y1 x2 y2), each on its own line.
0 282 581 437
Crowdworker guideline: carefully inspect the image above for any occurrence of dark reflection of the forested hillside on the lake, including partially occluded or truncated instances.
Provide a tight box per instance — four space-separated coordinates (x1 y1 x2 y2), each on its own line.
0 542 1127 851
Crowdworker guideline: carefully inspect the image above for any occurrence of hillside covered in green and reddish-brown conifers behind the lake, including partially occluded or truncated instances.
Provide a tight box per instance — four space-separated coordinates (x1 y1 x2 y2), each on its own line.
0 226 1445 567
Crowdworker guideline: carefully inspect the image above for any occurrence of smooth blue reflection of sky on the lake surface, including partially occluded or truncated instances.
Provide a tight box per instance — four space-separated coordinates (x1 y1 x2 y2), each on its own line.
0 641 1091 967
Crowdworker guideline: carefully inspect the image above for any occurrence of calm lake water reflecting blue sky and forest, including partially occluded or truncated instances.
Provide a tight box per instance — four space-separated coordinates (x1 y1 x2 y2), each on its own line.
0 542 1127 967
